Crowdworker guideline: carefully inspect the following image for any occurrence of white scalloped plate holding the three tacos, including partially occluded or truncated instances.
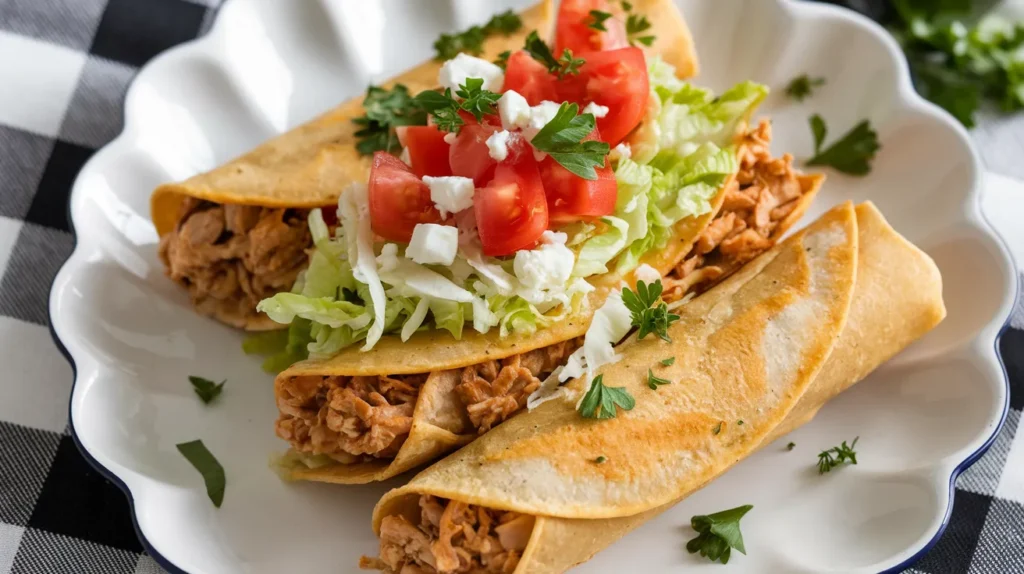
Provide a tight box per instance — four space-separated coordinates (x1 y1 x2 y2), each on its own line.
50 0 1016 573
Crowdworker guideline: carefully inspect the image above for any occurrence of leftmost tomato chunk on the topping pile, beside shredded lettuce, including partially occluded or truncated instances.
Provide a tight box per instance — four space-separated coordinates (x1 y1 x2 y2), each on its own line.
370 151 441 242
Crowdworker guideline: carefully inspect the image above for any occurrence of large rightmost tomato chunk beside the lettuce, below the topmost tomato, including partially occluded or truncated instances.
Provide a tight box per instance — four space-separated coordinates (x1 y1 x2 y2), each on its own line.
558 47 650 146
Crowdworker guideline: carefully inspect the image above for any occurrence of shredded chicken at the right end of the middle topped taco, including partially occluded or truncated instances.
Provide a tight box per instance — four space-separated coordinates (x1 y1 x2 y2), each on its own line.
663 120 806 302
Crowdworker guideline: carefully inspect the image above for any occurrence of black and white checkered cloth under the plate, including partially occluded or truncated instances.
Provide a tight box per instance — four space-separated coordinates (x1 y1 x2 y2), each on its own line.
0 0 1024 574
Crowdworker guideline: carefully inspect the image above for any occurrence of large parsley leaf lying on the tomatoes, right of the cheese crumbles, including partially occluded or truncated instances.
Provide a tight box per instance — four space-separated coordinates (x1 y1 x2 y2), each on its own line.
530 102 610 181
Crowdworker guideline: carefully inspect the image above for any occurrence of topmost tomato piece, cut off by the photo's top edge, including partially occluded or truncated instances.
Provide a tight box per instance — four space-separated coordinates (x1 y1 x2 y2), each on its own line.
554 0 630 57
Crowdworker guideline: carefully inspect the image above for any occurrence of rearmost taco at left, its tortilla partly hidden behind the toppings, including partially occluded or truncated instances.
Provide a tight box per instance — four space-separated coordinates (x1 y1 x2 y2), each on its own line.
151 0 553 330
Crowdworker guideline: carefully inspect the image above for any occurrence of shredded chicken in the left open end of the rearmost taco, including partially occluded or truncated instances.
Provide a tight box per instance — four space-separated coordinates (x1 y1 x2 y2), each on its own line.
160 197 312 326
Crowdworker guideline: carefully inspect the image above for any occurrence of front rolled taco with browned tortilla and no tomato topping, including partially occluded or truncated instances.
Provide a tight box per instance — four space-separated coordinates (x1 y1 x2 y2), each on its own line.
361 204 945 574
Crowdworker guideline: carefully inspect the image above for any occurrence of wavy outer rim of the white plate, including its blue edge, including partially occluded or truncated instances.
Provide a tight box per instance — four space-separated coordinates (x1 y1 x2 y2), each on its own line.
46 0 1022 574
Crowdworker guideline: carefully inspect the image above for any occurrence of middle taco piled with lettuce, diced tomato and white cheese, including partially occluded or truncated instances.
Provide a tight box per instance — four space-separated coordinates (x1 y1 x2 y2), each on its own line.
259 0 823 483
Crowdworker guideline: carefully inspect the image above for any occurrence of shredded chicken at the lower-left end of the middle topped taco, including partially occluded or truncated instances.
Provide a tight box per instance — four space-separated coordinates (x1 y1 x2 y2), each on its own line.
276 340 583 463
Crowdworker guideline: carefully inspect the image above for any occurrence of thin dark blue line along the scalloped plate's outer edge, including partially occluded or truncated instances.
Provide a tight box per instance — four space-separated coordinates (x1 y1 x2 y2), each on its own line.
46 2 1021 574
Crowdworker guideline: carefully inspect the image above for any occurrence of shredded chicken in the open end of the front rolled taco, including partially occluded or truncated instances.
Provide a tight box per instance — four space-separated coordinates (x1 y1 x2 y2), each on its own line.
359 495 535 574
